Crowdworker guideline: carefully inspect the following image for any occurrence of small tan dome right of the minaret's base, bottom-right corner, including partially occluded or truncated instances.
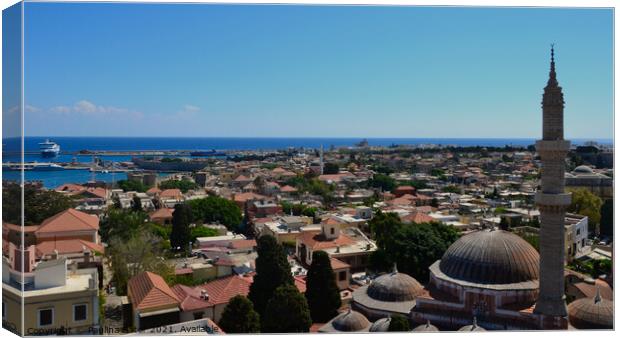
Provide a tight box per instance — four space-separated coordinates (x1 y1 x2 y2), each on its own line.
568 288 614 329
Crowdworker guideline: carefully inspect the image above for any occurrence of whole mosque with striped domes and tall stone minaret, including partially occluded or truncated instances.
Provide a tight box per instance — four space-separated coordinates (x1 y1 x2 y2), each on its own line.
319 47 613 332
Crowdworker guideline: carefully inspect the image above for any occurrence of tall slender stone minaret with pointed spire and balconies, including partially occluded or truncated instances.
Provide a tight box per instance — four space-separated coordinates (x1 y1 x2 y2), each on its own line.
534 45 571 329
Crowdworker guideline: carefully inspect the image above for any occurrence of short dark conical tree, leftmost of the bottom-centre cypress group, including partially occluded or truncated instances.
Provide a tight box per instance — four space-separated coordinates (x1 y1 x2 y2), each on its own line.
218 295 260 333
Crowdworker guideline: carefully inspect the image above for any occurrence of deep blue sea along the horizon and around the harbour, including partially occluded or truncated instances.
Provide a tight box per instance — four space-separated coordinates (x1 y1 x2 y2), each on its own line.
2 137 613 188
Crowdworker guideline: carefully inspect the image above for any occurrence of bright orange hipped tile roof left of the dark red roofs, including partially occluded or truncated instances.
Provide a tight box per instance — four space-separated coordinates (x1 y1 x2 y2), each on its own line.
127 271 180 310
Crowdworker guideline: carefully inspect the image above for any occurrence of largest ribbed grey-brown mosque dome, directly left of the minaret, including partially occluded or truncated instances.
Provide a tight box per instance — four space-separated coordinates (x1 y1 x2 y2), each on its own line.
439 230 540 284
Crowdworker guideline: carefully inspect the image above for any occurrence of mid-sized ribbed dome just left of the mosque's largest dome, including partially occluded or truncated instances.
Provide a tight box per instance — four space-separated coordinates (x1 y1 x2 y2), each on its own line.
366 269 424 302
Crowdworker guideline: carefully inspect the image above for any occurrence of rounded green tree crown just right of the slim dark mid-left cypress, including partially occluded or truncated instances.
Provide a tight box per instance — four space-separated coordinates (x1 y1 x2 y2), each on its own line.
187 196 243 232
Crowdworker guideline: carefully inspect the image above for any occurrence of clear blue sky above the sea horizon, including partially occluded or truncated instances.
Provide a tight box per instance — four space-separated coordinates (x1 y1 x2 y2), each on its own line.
17 3 613 138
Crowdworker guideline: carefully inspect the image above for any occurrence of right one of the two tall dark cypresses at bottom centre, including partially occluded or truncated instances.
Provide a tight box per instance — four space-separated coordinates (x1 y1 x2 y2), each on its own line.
305 251 341 323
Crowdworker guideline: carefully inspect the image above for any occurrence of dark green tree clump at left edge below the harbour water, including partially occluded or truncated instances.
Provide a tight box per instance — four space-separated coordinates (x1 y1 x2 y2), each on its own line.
2 183 75 225
